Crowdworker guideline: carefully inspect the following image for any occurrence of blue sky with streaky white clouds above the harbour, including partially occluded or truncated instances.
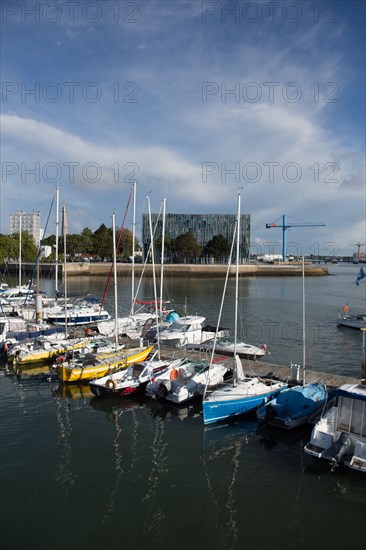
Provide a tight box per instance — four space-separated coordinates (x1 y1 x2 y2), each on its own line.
0 0 366 255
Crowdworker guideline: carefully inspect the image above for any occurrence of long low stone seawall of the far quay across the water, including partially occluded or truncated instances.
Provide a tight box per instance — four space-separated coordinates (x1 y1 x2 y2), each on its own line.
62 262 329 279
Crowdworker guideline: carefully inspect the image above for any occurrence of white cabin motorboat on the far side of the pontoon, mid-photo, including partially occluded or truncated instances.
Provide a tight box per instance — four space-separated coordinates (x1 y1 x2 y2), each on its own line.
159 315 227 348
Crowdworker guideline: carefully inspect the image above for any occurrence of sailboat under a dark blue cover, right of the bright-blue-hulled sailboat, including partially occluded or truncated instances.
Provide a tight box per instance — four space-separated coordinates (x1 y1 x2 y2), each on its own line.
257 257 328 430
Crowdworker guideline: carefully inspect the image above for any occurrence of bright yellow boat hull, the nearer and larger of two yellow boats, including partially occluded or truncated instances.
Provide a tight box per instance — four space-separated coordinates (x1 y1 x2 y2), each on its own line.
57 346 154 382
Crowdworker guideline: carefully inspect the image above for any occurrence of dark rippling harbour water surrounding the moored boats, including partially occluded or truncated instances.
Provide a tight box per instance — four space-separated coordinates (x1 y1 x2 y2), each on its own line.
0 264 366 550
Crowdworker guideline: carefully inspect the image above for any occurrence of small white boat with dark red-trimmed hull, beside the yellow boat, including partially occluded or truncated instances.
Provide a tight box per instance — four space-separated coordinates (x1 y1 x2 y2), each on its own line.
89 358 186 397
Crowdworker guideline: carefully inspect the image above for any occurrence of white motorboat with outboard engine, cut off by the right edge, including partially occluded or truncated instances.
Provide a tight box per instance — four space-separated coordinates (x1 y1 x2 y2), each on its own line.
305 384 366 473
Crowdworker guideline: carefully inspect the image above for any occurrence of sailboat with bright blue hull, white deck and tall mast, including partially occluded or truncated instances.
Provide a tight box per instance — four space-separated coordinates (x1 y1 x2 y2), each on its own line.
202 193 287 425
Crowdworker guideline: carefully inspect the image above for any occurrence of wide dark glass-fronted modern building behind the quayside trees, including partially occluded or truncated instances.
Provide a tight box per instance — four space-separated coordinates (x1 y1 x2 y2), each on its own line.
142 214 250 260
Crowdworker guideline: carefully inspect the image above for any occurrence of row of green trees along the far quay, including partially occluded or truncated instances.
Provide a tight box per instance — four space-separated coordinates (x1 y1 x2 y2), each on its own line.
0 224 230 263
